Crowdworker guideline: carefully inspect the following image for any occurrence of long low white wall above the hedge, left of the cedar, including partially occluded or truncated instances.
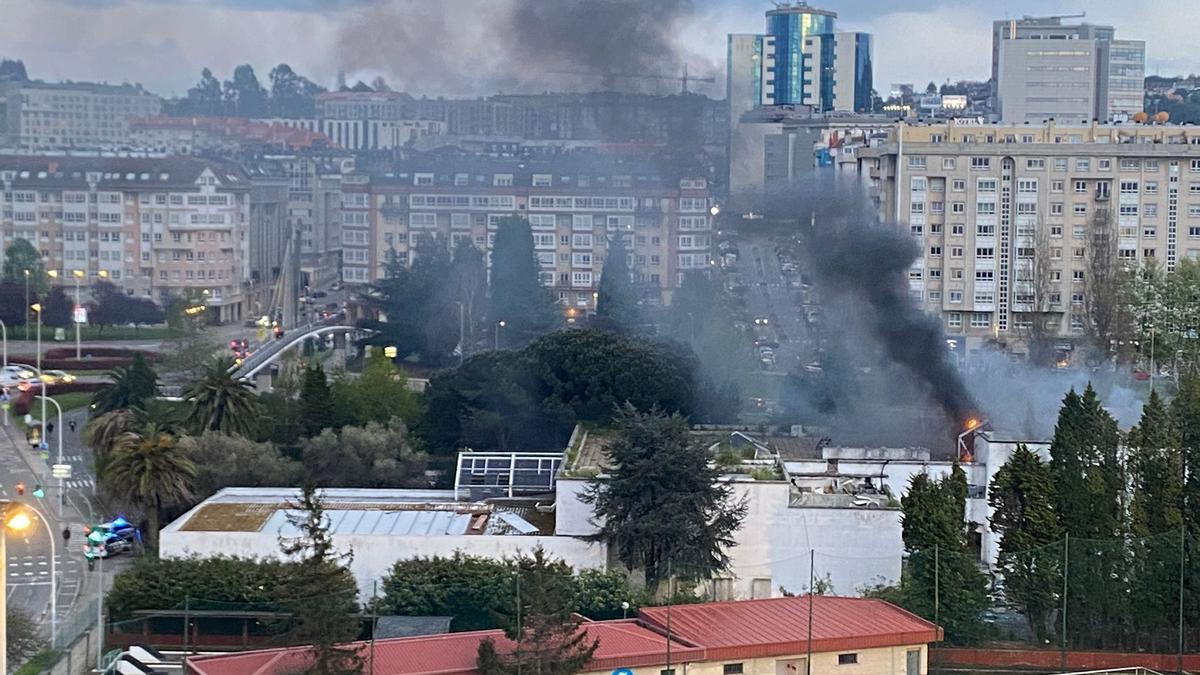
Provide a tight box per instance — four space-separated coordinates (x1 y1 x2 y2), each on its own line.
158 530 607 598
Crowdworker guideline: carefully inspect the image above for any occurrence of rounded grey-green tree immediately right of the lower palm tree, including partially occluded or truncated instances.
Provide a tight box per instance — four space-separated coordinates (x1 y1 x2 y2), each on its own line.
179 431 304 501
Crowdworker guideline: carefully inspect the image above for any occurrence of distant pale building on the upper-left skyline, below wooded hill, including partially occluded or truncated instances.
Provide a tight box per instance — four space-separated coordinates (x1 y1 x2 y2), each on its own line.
0 80 162 150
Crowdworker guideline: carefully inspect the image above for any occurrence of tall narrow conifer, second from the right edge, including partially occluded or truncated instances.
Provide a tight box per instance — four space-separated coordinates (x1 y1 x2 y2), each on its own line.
1127 390 1183 649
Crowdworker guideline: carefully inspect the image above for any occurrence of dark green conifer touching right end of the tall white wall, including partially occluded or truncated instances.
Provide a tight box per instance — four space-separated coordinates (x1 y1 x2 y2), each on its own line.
900 465 988 644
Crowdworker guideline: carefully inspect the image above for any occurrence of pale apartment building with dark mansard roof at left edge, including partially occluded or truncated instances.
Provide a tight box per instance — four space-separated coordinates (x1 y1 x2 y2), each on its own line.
0 155 250 321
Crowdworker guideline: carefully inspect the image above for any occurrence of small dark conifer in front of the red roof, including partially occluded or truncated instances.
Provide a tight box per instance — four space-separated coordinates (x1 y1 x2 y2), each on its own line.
476 546 600 675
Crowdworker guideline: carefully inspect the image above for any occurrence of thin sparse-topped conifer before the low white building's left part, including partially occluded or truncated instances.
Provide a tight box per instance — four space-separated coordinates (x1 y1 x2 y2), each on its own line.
280 483 362 675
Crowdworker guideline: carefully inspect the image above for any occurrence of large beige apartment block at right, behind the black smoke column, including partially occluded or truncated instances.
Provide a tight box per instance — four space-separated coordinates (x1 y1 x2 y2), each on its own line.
860 120 1200 352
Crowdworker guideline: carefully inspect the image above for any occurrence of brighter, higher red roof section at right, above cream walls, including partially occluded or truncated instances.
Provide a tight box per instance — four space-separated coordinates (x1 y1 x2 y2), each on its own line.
638 596 942 659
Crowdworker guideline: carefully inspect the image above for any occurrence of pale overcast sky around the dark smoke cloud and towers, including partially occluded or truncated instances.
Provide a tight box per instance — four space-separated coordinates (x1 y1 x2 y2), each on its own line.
0 0 1200 96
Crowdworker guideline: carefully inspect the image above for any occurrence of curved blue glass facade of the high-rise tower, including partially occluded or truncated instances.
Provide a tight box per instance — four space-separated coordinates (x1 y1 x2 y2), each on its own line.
767 5 838 104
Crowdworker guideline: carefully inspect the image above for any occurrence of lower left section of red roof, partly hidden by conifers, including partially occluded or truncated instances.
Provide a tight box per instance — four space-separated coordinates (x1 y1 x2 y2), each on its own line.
187 620 704 675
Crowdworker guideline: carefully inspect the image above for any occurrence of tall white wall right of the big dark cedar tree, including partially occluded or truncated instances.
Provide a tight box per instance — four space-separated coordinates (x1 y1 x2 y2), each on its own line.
730 480 904 598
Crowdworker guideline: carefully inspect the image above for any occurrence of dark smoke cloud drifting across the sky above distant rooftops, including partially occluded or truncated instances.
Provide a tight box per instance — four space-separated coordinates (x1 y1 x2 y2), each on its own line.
338 0 714 94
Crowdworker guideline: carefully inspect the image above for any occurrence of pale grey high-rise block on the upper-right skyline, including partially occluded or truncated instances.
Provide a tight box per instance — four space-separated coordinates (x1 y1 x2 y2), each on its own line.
991 17 1146 124
